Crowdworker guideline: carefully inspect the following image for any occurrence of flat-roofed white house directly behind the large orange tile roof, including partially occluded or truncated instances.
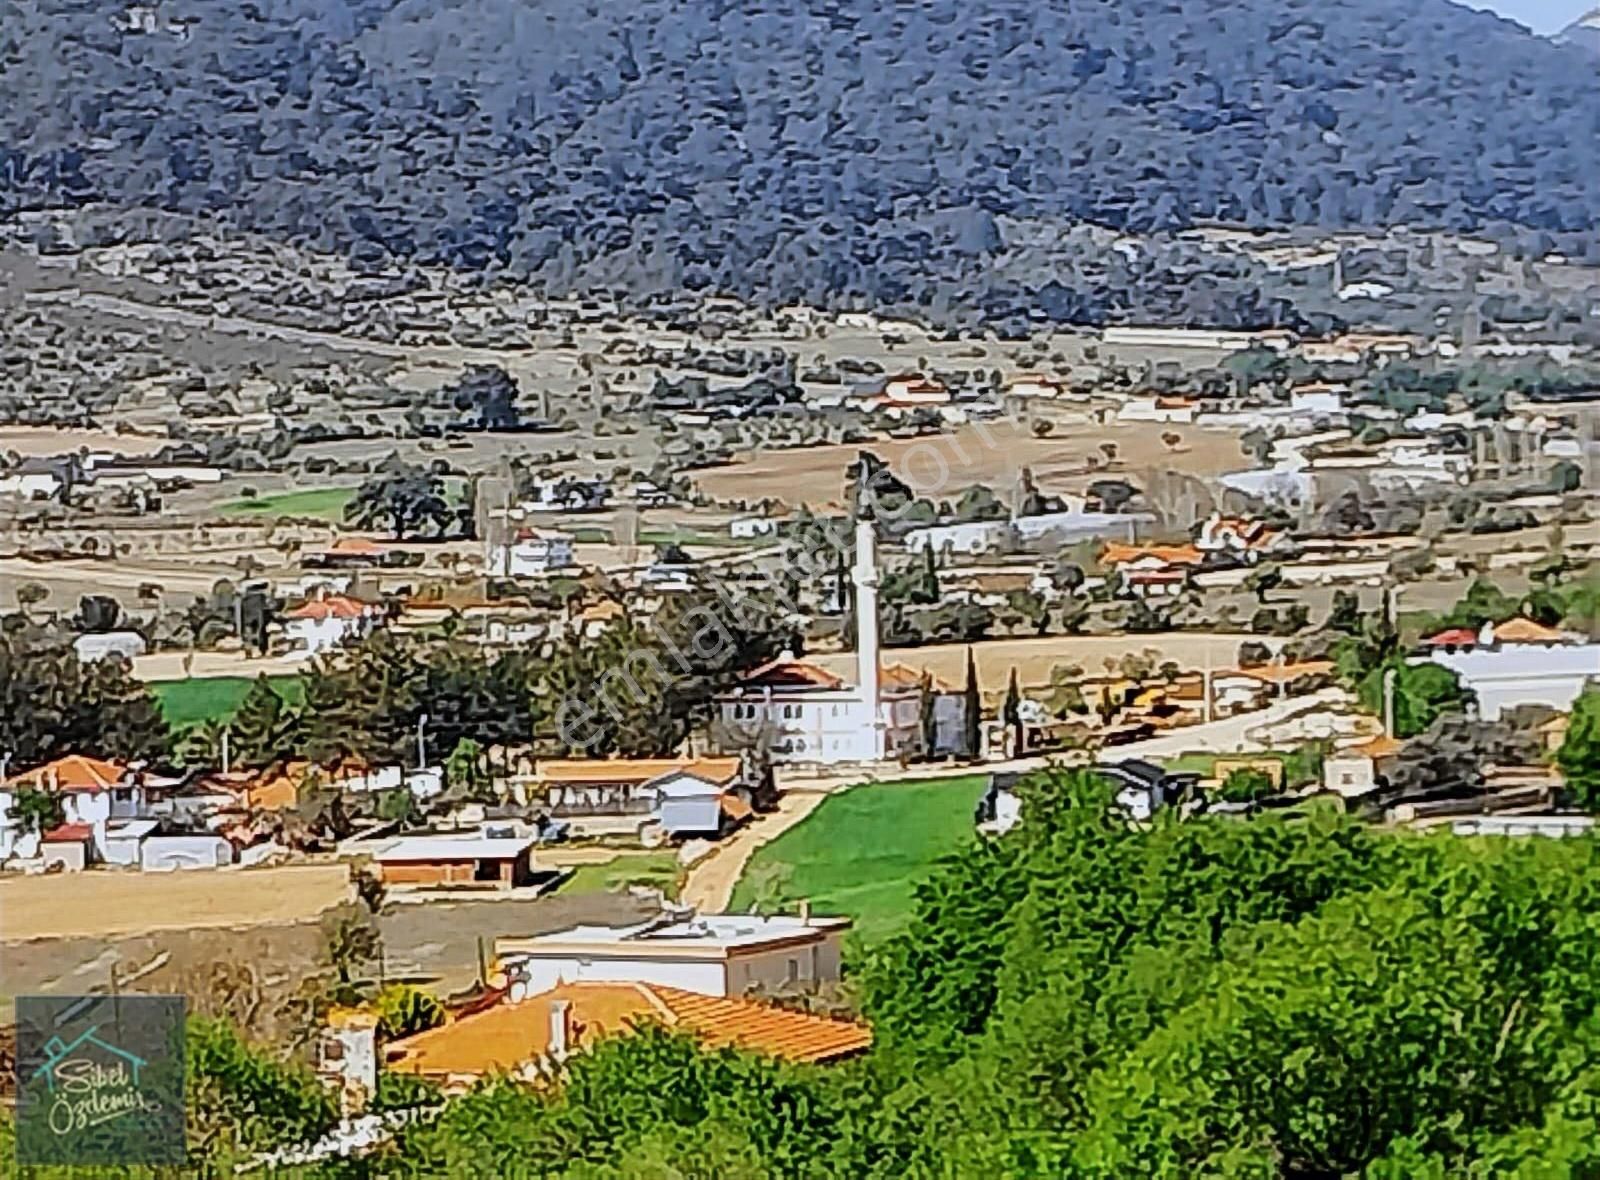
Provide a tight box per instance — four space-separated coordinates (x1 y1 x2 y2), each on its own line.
494 911 850 999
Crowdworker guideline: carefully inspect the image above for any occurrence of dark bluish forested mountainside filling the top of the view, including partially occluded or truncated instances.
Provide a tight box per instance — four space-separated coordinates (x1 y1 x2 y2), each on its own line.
0 0 1600 318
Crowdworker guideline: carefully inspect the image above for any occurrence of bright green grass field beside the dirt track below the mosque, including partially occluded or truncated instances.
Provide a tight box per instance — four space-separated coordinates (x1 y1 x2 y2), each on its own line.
730 774 989 943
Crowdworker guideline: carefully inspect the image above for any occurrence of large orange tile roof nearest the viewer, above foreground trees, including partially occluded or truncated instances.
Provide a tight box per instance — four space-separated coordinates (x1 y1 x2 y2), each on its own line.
387 983 872 1078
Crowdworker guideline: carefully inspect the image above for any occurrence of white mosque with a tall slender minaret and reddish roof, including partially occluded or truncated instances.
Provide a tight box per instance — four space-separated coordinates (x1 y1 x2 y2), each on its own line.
717 520 922 766
